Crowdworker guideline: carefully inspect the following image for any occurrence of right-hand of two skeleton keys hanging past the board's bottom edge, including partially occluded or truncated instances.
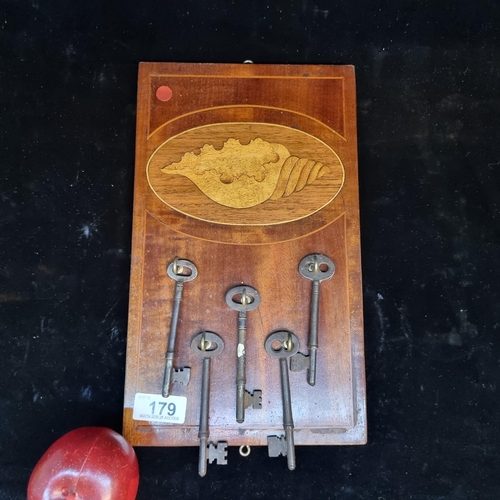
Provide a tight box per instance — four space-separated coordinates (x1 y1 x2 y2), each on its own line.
264 330 299 470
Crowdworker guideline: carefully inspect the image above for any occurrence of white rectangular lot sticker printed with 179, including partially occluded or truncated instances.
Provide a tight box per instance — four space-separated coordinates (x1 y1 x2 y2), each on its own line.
132 392 187 424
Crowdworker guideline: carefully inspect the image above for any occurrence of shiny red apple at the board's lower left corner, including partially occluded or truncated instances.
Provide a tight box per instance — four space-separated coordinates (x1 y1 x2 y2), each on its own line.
28 427 139 500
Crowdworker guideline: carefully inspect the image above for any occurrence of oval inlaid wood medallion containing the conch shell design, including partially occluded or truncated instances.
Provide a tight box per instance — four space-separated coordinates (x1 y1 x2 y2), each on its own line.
146 123 345 226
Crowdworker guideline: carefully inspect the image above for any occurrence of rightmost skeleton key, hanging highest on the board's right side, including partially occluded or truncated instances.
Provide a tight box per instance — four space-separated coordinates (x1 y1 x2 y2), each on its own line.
291 253 335 385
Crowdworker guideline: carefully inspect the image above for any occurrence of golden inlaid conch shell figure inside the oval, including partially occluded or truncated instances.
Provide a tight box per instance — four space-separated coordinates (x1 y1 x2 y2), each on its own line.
161 137 330 208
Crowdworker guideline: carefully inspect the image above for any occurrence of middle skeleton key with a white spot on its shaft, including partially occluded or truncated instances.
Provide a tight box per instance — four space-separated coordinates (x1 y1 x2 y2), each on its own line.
226 285 262 424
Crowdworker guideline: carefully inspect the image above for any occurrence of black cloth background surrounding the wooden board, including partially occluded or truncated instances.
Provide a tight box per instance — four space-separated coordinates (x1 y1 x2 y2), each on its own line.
0 0 500 500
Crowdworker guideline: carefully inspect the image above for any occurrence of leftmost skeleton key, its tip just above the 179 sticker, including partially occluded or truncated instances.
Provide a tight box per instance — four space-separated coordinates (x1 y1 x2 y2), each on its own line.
162 257 198 398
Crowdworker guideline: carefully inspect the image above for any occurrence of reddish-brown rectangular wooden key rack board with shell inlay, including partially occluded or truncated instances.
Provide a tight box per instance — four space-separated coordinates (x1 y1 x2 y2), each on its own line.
124 63 366 454
